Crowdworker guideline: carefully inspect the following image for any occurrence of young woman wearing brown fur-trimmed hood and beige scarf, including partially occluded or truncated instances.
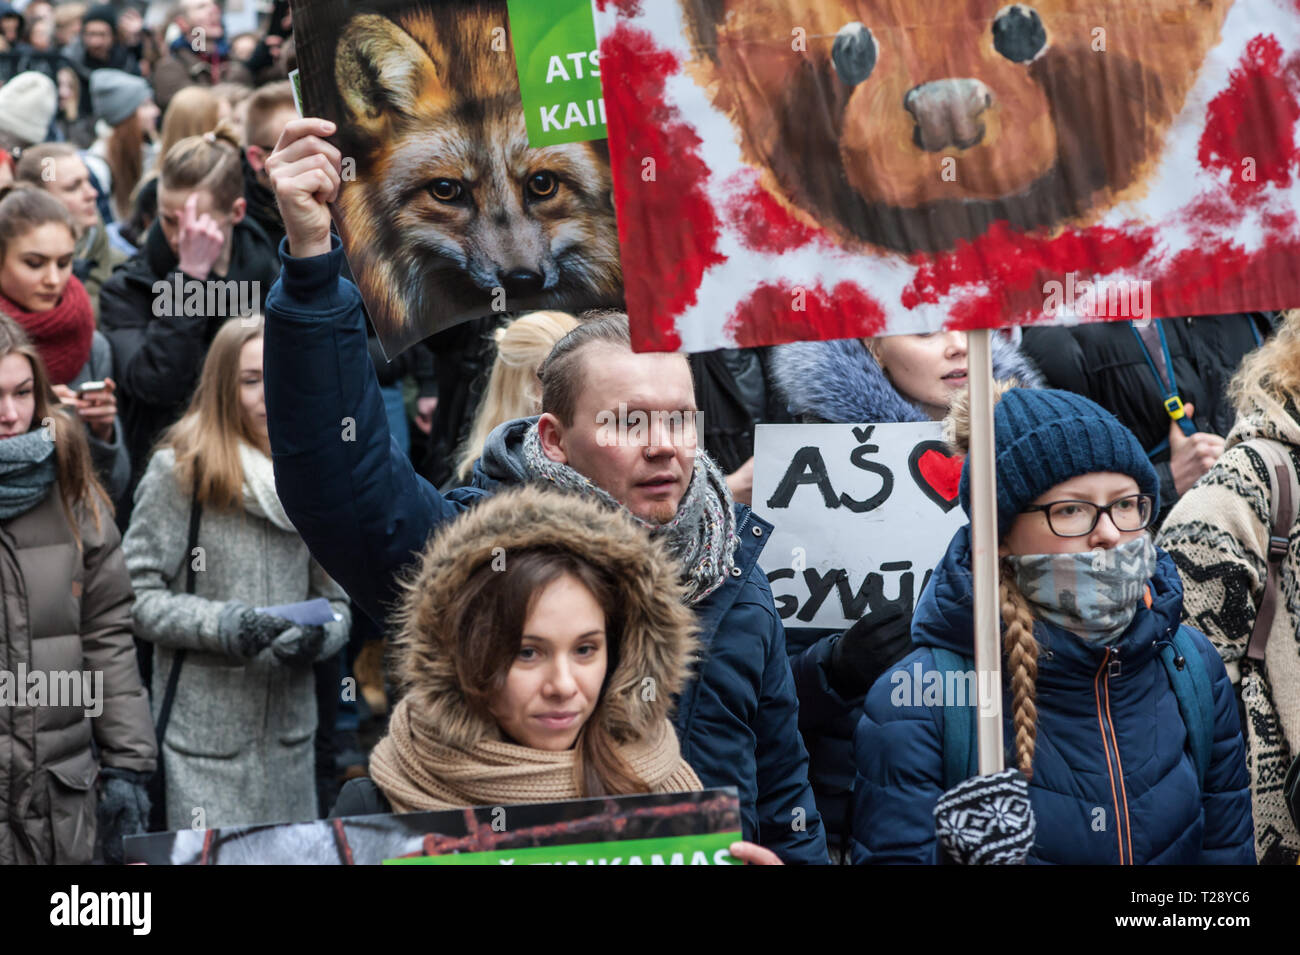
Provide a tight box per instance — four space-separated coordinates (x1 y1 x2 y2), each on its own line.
333 487 779 863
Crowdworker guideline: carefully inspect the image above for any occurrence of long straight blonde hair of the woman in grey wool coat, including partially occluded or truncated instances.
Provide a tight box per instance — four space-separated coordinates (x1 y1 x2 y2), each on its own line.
159 314 263 511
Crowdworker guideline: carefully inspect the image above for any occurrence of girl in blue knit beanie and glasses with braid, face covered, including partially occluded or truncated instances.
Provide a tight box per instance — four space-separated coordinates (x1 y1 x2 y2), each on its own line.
853 387 1255 864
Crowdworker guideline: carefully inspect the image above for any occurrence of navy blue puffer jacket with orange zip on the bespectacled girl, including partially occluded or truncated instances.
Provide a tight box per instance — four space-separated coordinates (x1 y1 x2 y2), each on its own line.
853 525 1255 865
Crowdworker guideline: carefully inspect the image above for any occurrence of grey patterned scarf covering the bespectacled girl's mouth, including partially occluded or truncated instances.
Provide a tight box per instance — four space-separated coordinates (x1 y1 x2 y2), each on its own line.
1004 534 1156 646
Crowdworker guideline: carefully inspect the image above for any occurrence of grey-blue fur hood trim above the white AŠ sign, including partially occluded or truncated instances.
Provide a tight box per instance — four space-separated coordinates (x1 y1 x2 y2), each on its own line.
772 335 1043 424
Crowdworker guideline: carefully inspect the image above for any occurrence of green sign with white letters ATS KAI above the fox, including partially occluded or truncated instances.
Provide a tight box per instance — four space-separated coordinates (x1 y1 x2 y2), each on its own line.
508 0 606 148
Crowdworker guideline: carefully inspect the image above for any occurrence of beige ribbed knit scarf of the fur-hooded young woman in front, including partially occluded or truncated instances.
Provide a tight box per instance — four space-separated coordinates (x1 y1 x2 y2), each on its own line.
371 699 703 812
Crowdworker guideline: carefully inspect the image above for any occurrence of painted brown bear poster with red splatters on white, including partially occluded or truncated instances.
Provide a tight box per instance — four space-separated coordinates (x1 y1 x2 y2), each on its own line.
594 0 1300 351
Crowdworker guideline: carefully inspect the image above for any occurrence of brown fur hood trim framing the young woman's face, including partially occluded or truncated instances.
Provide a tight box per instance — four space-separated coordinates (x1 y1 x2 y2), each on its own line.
394 486 697 750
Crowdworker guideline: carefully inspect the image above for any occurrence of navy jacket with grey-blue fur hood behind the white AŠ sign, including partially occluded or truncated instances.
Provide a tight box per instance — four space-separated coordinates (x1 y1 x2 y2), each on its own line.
771 335 1043 846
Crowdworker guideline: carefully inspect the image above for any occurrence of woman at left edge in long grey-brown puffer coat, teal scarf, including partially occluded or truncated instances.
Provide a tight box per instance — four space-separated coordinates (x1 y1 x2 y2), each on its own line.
0 315 157 865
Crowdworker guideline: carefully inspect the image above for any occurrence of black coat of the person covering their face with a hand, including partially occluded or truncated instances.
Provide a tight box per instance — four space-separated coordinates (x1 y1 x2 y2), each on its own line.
99 218 280 525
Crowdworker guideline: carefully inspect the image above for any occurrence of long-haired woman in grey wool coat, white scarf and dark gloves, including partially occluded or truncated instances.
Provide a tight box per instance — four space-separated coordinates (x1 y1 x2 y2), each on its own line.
122 316 351 829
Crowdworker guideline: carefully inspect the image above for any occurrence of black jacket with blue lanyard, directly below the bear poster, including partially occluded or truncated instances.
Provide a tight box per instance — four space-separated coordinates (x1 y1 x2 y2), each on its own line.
1021 312 1274 522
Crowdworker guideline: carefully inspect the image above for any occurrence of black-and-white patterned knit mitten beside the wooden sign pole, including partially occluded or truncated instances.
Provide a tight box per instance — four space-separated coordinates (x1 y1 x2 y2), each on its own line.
935 767 1037 865
